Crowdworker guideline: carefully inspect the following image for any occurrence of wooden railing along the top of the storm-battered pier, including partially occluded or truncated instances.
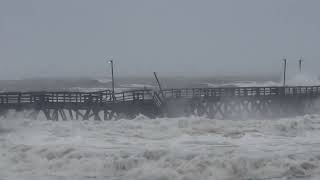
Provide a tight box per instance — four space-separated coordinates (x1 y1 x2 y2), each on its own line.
0 86 320 106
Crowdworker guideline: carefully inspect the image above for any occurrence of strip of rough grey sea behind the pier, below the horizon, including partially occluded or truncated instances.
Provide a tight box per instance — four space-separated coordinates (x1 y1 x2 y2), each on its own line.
0 73 320 92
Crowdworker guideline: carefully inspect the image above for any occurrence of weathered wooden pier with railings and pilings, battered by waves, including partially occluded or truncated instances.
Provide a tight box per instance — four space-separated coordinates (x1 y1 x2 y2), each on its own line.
0 86 320 121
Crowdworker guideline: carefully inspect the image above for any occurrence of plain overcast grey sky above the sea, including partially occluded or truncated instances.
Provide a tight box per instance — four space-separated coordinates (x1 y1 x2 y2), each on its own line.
0 0 320 79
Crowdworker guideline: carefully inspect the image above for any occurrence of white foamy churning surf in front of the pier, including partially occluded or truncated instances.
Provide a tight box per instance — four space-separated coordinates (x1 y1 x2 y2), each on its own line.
0 115 320 180
